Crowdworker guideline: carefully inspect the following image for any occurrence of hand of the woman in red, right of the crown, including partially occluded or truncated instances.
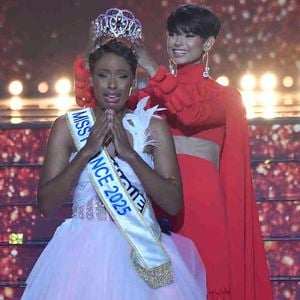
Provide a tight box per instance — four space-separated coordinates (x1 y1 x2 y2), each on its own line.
132 40 158 77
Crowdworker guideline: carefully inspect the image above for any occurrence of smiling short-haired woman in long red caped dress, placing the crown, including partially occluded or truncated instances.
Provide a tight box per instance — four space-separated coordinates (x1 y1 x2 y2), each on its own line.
75 5 272 300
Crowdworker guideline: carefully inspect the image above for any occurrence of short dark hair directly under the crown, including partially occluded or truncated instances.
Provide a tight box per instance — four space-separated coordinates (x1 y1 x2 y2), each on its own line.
89 40 137 75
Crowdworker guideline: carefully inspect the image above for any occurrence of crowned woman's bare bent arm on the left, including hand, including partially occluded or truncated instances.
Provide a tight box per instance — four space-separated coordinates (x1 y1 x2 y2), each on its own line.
37 113 108 215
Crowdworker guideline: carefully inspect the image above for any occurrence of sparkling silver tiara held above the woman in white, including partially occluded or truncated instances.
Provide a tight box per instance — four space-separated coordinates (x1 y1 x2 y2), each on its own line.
91 8 142 48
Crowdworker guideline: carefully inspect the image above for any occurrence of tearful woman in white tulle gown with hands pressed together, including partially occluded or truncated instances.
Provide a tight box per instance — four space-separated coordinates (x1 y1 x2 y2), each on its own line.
22 8 206 300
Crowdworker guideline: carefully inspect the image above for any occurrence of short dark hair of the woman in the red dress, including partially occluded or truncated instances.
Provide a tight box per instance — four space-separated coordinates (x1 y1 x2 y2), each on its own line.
167 4 221 39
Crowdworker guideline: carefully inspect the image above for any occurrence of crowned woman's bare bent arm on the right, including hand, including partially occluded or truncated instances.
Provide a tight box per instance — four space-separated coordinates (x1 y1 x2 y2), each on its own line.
112 114 183 215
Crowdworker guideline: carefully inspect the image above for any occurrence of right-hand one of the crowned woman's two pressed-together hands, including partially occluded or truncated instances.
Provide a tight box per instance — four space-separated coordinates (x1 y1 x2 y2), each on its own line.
108 110 135 161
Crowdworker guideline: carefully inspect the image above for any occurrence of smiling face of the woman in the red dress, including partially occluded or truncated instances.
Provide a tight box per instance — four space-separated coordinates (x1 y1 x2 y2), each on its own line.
167 32 204 65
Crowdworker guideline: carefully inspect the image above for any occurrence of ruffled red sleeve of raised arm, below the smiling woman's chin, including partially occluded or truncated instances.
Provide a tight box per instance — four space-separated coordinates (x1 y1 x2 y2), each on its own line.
149 67 226 127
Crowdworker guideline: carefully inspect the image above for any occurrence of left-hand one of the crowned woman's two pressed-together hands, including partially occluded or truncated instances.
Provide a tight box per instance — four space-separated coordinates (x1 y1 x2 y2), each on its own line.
82 114 110 157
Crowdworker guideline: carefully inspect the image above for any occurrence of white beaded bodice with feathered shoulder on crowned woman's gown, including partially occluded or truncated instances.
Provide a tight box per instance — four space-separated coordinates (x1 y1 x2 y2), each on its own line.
70 98 159 220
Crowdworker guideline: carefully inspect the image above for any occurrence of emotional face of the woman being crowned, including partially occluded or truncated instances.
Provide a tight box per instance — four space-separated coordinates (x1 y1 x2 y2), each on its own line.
92 53 134 112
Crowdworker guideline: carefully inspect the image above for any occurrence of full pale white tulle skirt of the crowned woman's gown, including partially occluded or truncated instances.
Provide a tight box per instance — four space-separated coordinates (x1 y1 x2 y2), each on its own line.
21 218 206 300
